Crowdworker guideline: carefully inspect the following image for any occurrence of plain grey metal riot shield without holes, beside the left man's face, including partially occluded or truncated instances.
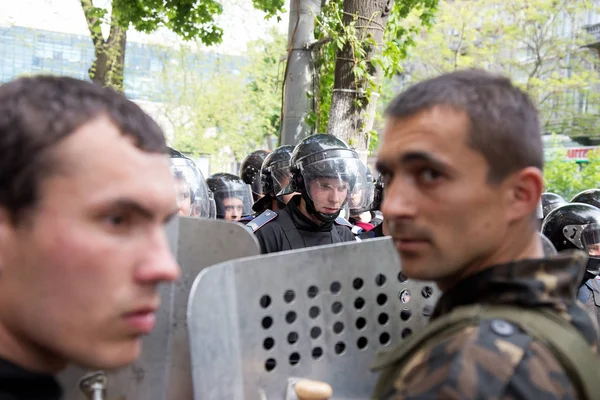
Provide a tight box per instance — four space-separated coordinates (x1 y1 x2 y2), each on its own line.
59 218 260 400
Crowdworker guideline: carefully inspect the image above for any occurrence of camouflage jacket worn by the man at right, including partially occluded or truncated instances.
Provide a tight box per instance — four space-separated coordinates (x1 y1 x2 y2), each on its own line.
372 252 600 400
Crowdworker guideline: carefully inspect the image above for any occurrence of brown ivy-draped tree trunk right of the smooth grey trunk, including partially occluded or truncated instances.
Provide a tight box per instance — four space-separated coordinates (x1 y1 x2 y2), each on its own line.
327 0 392 161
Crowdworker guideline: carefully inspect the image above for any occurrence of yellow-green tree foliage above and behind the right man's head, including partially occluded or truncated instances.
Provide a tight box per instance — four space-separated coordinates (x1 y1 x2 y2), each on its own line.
398 0 600 136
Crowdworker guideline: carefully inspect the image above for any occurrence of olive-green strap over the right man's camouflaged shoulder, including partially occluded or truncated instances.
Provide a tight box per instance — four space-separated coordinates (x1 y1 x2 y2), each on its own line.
373 305 600 400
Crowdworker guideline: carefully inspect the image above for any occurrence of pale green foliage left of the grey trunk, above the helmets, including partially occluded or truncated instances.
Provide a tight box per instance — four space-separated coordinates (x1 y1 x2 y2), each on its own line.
156 32 286 172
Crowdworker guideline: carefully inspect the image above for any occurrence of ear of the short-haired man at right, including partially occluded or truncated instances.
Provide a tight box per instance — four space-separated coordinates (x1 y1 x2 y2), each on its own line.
505 167 544 222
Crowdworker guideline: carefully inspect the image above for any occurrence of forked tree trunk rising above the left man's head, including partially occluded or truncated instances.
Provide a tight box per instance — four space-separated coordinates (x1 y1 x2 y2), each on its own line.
81 0 127 92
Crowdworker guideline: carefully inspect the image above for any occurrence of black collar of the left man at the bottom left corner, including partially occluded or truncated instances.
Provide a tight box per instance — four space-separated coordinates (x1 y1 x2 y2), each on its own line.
0 358 62 400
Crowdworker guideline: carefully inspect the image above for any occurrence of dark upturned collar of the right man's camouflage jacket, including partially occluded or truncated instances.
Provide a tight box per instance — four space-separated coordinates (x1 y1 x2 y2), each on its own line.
431 251 587 318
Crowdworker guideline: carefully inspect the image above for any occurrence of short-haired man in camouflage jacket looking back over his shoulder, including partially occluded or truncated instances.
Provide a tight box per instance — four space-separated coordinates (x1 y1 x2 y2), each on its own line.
375 70 600 400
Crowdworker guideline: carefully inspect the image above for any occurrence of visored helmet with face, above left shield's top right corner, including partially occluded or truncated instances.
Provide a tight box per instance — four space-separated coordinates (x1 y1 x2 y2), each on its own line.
206 172 252 221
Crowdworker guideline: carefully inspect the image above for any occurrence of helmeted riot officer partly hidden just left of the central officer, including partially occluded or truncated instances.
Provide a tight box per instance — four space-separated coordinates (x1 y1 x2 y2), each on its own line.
252 145 294 214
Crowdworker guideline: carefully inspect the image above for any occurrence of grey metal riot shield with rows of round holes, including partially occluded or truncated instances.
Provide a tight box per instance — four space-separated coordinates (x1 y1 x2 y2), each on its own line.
188 238 438 400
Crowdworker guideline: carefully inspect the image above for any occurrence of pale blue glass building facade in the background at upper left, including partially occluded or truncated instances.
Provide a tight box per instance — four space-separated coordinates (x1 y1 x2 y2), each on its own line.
0 26 243 102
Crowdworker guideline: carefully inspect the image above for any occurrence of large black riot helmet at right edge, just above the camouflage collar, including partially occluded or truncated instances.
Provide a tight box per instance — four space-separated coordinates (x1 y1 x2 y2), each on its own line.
542 203 600 280
